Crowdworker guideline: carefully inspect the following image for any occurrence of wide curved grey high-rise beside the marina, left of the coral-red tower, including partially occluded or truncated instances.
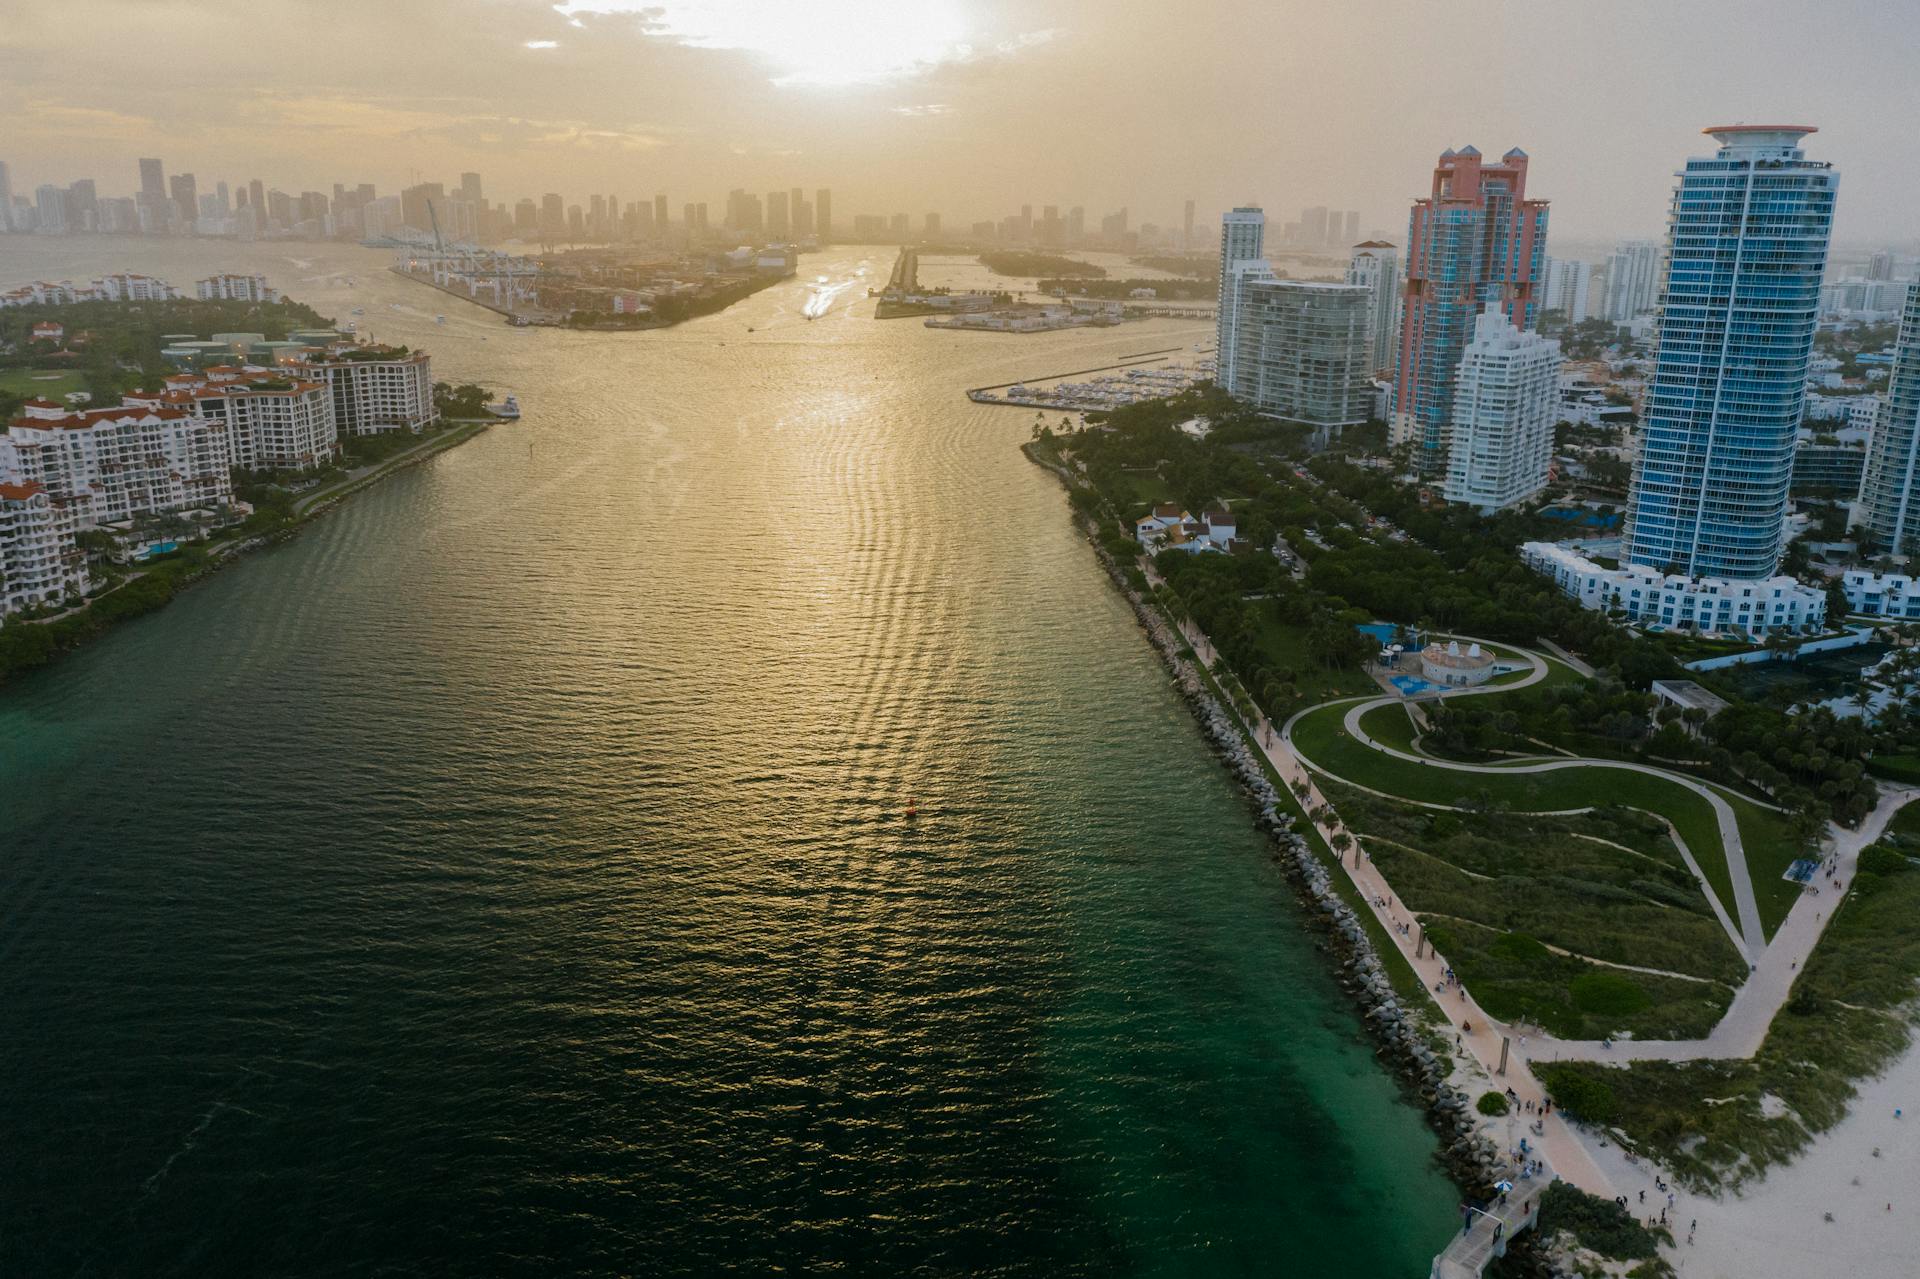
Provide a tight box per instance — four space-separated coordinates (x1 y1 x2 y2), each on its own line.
1229 270 1373 428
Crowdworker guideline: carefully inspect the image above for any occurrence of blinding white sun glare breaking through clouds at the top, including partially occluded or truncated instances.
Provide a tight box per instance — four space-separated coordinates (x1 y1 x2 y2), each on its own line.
553 0 972 86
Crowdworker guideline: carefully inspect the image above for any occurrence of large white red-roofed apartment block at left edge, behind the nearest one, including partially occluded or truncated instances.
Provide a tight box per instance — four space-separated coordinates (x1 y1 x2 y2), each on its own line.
0 399 232 528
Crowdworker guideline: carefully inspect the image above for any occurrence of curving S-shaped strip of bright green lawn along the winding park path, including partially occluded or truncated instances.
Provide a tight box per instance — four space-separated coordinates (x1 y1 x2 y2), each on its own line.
1294 703 1758 924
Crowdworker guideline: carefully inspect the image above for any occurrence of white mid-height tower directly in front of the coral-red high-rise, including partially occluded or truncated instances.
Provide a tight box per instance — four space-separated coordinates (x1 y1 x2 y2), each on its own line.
1444 305 1559 511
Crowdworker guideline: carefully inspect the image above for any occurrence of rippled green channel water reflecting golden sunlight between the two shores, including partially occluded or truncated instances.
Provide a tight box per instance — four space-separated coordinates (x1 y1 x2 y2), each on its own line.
0 236 1453 1275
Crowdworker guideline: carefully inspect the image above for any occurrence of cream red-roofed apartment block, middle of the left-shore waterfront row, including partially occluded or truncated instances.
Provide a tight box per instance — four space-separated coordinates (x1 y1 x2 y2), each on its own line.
127 367 340 471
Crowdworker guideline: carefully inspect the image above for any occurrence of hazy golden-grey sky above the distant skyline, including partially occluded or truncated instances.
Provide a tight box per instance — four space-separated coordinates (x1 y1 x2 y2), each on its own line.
0 0 1920 242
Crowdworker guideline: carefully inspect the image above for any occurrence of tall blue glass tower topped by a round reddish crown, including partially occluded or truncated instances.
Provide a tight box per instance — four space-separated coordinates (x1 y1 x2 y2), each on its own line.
1622 125 1839 580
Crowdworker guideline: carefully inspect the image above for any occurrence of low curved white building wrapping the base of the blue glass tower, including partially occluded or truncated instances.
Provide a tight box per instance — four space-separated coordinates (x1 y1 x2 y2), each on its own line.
1521 542 1826 636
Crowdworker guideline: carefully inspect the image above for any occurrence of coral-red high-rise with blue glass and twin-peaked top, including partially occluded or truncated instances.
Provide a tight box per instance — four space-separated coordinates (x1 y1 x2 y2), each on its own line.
1392 146 1548 476
